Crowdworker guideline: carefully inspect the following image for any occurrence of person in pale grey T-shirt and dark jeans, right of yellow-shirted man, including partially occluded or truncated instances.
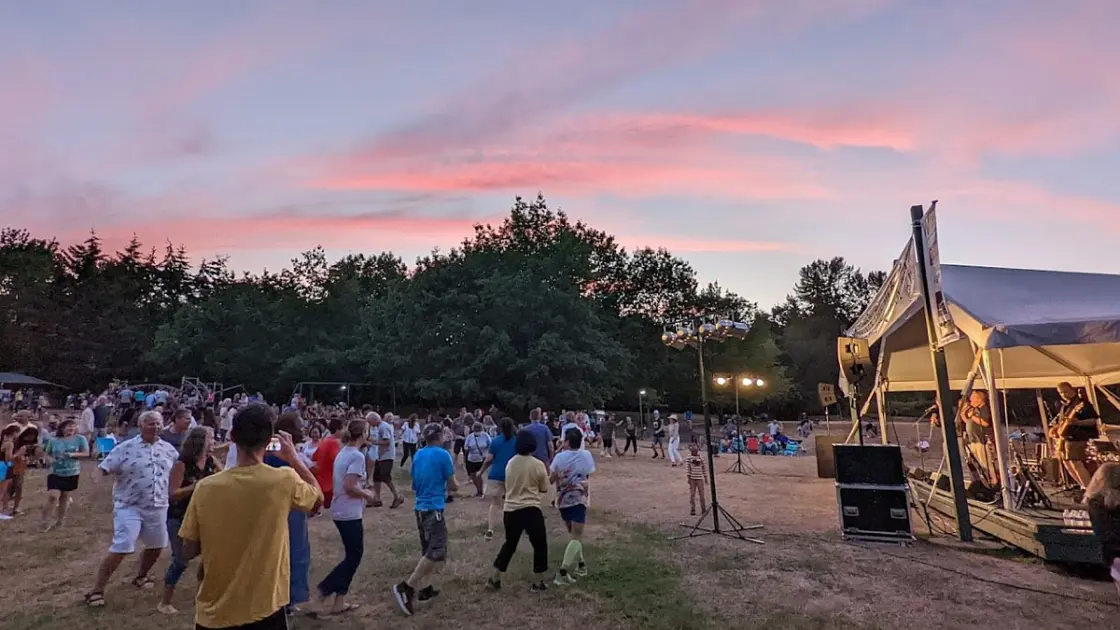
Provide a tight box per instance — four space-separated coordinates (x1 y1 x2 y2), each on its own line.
318 420 373 615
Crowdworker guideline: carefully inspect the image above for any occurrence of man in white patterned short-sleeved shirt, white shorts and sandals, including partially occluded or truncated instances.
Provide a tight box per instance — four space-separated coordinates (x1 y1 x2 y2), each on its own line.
85 411 179 606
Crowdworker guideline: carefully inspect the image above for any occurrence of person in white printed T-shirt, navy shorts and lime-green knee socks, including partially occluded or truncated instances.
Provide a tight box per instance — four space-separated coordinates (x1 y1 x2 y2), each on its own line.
549 428 595 586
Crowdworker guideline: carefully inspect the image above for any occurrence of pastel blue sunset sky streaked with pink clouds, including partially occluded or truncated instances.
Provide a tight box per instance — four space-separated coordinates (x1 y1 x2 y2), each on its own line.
0 0 1120 307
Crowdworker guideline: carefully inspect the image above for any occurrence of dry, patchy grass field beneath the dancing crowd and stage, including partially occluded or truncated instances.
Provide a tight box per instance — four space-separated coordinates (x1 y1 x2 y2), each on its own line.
0 434 1118 630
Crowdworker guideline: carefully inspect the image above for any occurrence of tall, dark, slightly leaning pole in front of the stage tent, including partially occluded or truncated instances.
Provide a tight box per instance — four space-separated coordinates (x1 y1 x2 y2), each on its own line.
911 205 972 543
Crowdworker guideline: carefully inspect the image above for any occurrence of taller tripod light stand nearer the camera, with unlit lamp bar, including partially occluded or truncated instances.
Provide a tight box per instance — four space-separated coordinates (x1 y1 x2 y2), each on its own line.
661 317 764 545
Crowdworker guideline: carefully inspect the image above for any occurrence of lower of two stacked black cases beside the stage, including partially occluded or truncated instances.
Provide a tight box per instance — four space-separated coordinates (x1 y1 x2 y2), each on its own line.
837 483 914 543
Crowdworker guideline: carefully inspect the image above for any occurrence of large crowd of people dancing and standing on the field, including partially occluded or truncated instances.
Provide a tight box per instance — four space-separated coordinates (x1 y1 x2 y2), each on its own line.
0 386 725 628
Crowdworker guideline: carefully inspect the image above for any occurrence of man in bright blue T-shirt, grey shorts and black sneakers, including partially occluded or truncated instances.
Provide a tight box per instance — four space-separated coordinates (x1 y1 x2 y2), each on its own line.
393 423 459 615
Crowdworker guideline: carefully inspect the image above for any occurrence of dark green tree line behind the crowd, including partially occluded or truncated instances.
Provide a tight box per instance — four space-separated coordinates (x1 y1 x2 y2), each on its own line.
0 196 884 411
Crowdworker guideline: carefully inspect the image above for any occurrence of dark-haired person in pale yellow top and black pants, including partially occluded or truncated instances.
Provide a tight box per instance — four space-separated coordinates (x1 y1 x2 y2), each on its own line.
486 429 549 593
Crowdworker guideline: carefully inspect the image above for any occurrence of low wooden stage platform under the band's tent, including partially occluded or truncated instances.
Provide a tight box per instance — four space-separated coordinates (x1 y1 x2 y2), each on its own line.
911 479 1102 565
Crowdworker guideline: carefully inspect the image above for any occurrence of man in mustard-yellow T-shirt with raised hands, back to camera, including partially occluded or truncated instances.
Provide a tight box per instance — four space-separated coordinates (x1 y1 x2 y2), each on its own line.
179 404 323 630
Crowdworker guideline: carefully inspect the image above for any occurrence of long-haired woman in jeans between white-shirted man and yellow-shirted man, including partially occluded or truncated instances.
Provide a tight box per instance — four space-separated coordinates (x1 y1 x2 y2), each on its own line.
156 427 222 614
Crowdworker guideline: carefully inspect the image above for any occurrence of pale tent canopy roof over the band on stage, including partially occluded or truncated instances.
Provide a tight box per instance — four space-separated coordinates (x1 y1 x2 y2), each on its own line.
849 265 1120 391
